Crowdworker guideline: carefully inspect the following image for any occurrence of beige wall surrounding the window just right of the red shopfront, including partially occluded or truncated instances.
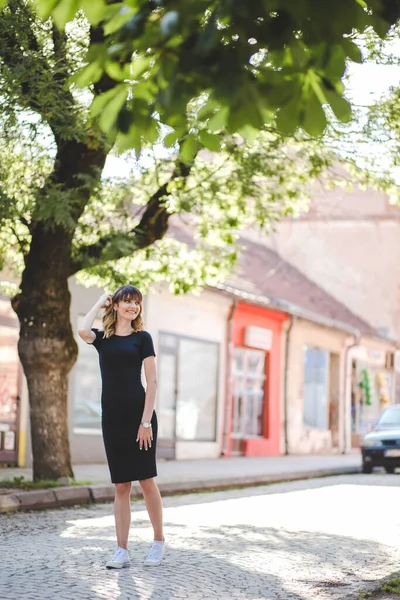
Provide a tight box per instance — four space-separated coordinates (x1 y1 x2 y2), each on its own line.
286 319 348 454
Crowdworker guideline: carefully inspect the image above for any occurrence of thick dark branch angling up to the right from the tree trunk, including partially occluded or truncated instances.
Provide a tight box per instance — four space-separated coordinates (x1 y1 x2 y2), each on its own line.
69 162 192 276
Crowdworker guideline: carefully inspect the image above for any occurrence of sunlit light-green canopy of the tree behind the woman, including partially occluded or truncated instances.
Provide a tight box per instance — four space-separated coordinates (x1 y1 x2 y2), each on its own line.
0 0 346 300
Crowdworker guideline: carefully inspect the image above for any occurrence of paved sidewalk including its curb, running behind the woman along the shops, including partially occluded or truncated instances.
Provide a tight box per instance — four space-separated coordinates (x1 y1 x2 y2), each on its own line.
0 453 360 513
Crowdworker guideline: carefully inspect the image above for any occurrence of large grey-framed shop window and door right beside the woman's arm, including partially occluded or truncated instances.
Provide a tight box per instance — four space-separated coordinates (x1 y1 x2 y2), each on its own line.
157 333 219 441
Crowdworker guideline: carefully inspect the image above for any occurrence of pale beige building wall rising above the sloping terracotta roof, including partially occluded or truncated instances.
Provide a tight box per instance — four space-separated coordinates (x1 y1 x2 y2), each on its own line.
247 219 400 339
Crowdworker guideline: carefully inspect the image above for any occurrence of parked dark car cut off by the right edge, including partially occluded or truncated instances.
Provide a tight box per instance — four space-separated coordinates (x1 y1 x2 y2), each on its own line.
361 404 400 473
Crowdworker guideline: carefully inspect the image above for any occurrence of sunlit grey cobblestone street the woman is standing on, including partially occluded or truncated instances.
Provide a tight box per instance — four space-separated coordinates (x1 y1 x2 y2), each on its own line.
0 473 400 600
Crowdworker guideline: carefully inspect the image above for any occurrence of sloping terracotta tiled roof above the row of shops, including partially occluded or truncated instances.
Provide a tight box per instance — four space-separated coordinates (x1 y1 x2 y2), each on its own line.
225 239 382 337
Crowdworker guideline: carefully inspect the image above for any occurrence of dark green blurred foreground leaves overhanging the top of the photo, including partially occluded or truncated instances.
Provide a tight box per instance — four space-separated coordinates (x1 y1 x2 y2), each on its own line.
10 0 400 163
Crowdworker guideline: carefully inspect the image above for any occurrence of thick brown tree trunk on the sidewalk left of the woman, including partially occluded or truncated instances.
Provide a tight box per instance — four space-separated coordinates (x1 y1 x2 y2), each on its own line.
12 223 78 481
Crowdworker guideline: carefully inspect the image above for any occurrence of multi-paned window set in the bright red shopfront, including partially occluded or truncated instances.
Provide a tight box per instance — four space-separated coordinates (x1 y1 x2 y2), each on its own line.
232 348 265 437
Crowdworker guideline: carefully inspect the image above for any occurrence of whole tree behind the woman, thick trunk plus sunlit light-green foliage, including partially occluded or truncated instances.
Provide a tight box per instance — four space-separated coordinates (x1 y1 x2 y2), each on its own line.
0 0 396 479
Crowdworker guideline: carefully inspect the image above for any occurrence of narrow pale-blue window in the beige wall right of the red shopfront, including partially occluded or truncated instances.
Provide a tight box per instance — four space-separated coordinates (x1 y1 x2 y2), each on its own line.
303 347 329 429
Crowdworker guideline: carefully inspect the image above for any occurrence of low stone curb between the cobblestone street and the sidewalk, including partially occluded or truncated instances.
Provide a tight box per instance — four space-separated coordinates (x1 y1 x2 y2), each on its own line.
0 467 361 514
